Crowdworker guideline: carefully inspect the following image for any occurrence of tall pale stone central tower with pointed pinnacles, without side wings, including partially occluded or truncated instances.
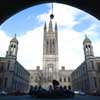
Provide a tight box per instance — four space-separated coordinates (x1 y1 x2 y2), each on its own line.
43 19 58 81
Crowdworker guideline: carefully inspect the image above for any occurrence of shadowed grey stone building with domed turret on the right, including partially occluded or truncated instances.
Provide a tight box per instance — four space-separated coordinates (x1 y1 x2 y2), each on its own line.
71 36 100 93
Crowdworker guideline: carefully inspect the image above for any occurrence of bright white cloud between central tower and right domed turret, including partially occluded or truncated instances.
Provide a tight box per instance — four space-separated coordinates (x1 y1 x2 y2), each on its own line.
59 29 84 69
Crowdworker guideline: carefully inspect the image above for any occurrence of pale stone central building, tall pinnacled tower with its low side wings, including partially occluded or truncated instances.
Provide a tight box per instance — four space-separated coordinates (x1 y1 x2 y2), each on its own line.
29 19 72 87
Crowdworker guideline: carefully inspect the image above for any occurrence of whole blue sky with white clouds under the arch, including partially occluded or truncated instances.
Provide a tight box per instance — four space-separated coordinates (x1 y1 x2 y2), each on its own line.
0 3 100 69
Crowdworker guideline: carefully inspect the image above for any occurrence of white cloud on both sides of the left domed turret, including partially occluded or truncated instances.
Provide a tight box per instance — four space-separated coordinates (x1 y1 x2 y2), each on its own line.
0 26 43 69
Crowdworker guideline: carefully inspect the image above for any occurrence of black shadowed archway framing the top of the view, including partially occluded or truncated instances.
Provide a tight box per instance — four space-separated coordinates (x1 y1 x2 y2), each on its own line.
0 0 100 24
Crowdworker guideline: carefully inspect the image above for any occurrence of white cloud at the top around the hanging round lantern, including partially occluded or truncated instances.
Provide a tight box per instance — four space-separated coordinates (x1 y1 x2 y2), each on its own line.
37 3 80 28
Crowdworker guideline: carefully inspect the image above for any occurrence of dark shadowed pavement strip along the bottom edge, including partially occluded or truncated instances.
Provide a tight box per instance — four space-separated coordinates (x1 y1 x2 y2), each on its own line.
0 96 100 100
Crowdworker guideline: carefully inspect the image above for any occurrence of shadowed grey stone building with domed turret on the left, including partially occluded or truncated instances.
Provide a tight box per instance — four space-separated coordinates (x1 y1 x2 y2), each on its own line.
0 36 30 92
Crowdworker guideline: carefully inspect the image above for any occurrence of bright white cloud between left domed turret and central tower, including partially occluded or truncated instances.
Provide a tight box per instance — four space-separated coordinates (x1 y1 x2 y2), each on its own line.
18 26 43 69
